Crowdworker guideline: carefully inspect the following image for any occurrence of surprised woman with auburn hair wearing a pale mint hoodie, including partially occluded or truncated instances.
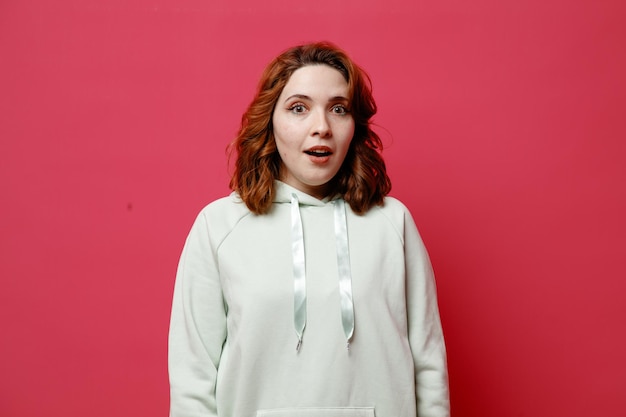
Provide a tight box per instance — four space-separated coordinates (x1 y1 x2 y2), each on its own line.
169 43 449 417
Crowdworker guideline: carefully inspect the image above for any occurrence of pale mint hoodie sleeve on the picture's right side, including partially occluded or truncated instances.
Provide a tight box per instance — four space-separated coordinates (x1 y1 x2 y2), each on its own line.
404 209 450 417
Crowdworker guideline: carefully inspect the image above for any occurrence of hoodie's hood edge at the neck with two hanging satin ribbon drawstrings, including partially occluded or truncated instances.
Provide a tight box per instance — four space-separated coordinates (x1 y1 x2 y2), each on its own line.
273 181 354 351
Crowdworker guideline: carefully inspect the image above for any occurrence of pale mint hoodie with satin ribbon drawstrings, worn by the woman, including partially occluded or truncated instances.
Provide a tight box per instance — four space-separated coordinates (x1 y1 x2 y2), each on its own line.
169 182 449 417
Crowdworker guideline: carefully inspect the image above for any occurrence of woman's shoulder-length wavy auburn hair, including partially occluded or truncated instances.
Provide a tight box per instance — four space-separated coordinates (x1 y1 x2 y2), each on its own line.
229 42 391 214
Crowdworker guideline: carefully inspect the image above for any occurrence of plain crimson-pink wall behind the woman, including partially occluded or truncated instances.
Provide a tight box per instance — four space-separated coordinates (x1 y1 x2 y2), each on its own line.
0 0 626 417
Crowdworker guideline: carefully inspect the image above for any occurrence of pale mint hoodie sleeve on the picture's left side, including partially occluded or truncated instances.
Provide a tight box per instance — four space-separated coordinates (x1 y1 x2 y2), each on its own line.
168 213 226 417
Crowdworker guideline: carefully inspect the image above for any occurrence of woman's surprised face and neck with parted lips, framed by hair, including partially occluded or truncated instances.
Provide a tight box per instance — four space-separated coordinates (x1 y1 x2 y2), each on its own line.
272 65 354 199
